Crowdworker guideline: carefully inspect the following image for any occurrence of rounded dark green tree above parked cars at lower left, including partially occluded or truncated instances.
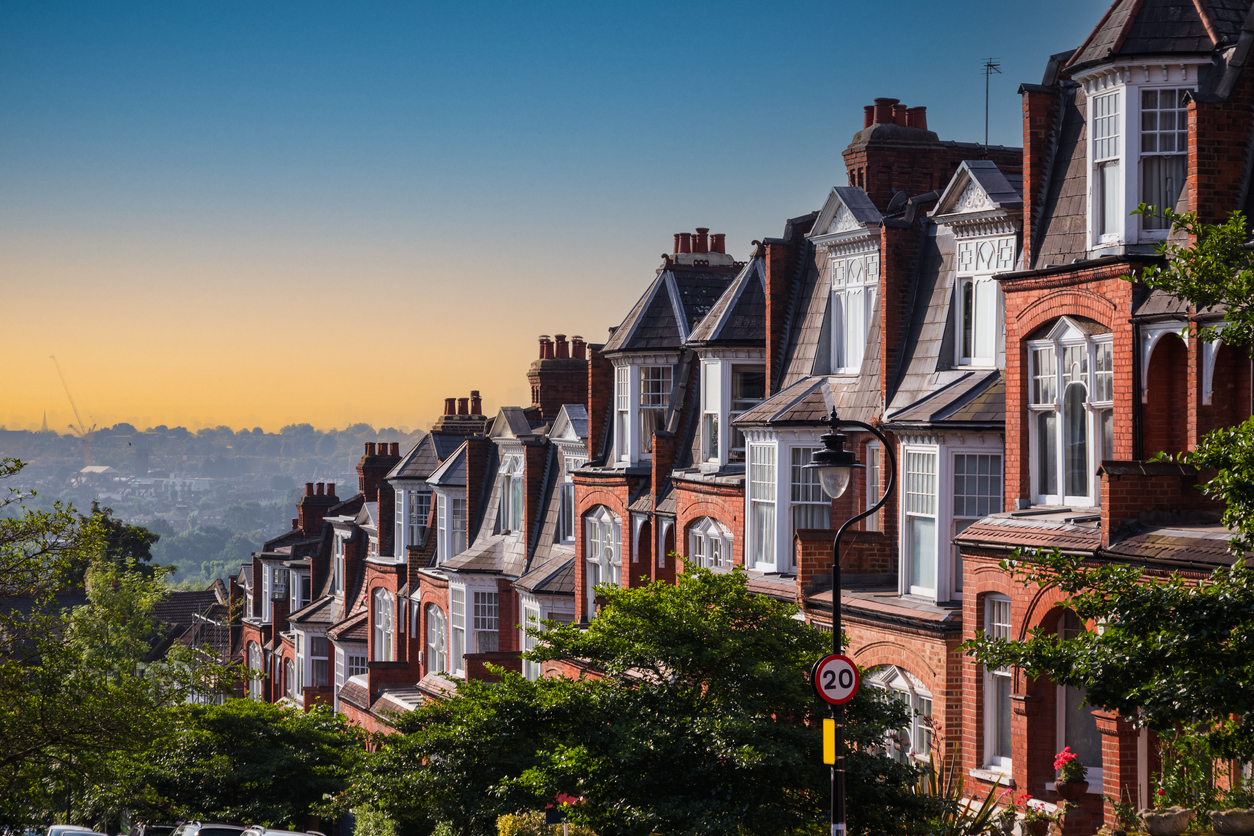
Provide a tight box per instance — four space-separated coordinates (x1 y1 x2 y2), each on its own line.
132 699 362 830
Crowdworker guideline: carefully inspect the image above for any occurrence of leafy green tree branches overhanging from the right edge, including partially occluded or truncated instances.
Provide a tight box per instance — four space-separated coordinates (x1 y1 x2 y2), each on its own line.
966 206 1254 762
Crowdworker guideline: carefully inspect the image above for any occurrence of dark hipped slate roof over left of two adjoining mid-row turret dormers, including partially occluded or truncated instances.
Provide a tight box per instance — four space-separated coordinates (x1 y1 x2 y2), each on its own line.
602 262 735 355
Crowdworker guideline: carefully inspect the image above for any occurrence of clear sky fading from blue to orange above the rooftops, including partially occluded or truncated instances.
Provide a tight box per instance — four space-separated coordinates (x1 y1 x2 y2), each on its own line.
0 0 1106 431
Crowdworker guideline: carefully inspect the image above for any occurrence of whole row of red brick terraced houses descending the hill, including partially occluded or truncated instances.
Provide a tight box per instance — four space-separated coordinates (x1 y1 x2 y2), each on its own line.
220 0 1254 833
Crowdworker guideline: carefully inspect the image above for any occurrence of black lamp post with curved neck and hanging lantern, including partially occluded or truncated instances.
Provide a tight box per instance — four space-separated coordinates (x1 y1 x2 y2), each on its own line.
805 409 897 836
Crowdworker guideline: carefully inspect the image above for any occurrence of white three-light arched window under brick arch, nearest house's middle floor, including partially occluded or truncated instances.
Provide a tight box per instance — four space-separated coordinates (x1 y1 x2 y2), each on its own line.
1028 317 1115 506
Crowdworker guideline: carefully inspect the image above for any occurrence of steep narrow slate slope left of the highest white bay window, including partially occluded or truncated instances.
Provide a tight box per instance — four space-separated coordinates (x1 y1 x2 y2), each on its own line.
1031 84 1088 269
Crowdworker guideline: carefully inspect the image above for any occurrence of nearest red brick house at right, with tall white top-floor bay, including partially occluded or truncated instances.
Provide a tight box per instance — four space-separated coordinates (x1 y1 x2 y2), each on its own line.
956 0 1254 833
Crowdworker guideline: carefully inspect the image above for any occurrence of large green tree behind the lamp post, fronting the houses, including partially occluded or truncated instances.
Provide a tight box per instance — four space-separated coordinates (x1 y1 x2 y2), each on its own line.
352 564 929 836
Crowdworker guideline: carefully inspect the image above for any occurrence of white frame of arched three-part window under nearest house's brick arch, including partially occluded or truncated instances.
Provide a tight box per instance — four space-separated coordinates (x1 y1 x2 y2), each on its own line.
1027 317 1114 508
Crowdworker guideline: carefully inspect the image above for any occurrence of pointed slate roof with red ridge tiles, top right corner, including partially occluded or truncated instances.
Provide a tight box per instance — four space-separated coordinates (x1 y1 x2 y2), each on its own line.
1067 0 1250 69
